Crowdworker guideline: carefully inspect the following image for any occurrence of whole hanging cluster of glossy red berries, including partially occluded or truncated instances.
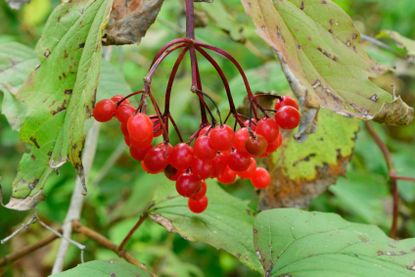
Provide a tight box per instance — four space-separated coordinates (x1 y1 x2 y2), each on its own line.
93 96 300 213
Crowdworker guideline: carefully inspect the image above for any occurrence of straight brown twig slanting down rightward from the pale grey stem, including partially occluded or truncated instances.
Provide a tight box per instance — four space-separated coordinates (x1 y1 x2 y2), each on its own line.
71 221 147 271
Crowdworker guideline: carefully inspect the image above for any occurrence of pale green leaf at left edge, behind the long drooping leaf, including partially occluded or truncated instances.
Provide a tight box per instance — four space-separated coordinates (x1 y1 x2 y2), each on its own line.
0 41 38 129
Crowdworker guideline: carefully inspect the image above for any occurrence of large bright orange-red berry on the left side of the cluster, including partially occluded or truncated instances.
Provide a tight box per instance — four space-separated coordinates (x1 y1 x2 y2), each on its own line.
127 113 153 144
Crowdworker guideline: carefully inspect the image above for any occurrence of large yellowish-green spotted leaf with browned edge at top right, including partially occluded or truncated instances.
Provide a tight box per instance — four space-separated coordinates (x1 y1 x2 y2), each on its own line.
242 0 413 125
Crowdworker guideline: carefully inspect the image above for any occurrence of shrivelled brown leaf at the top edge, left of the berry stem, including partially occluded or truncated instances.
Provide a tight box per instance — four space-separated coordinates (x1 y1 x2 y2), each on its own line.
103 0 164 45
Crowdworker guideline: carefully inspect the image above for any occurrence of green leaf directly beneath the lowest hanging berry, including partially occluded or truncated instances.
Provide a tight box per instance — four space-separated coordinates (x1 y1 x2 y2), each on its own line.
150 180 261 271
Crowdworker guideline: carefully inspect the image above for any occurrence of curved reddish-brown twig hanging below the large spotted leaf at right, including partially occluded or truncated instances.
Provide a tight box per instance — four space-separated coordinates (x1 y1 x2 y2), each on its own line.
365 121 399 238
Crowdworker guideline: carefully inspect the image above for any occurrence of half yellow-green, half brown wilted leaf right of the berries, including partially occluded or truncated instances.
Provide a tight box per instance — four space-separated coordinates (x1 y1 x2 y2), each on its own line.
261 110 359 208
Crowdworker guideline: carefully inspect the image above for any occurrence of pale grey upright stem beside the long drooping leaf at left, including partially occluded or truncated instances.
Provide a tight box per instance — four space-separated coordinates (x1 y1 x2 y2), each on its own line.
52 121 99 274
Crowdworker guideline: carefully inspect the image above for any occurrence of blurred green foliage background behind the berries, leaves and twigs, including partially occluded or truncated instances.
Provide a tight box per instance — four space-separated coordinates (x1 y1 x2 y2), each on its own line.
0 0 415 276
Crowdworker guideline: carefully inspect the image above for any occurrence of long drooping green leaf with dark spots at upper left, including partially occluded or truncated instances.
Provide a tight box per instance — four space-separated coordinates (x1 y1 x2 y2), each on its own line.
7 0 112 210
